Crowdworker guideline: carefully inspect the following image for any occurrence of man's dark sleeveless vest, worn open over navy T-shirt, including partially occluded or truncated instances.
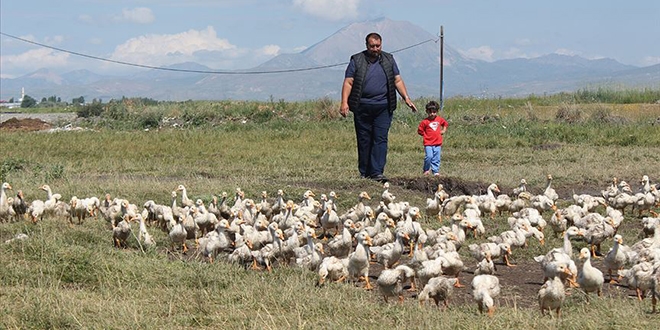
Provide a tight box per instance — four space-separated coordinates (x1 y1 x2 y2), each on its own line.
348 50 396 112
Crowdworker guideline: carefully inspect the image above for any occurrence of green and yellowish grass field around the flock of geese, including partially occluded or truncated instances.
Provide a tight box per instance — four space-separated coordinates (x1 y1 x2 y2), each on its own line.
0 94 660 329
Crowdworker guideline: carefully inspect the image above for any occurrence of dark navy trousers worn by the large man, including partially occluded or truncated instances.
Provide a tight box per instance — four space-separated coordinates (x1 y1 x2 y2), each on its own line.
353 104 392 177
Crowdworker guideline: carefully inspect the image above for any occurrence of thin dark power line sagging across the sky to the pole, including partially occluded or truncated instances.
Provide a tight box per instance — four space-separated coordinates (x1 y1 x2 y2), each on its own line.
0 32 437 75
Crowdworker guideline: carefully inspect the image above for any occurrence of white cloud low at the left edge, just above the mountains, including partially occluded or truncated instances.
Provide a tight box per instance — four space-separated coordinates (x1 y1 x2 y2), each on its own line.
0 48 69 75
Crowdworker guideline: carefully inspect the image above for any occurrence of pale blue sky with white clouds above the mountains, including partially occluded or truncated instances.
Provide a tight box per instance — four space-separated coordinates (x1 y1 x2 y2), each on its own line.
0 0 660 78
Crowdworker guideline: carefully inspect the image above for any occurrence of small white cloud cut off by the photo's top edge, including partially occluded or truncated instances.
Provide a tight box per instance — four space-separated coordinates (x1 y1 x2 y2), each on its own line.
293 0 360 21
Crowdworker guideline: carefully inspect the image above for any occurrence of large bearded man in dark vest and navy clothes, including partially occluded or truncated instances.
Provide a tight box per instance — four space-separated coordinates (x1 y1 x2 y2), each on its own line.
339 33 417 182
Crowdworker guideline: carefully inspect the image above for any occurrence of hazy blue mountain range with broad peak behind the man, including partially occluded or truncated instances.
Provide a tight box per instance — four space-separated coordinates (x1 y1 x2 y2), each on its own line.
0 18 660 101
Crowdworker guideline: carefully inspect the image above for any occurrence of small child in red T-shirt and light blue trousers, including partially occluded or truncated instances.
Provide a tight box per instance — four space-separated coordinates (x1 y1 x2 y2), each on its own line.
417 101 449 175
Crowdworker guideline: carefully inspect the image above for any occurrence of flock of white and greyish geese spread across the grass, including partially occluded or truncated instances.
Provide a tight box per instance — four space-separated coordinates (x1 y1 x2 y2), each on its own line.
0 175 660 316
